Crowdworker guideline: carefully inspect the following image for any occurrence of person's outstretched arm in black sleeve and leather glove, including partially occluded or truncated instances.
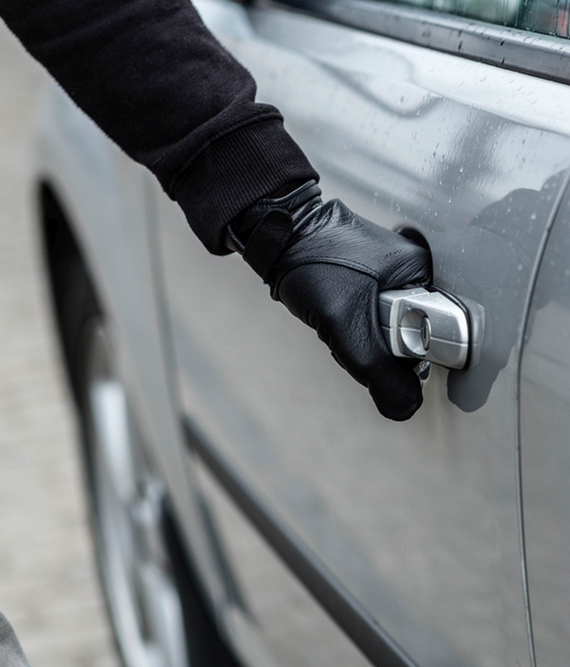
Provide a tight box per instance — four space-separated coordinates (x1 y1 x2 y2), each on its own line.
0 0 430 419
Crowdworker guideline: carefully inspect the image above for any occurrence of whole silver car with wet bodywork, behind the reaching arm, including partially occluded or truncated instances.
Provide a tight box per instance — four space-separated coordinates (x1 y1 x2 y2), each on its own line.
33 0 570 667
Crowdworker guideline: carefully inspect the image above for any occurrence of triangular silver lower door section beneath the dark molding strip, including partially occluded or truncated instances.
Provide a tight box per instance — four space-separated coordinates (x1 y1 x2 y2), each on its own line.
196 462 374 667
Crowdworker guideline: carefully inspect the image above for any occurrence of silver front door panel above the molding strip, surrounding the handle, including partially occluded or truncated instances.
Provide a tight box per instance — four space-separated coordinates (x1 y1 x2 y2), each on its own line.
153 2 570 667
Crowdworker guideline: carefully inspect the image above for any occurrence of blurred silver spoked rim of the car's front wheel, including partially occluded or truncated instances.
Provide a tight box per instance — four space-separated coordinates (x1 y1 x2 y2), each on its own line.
76 308 189 667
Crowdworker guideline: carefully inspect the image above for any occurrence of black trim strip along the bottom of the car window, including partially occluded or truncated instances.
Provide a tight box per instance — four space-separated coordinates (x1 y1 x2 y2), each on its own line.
253 0 570 83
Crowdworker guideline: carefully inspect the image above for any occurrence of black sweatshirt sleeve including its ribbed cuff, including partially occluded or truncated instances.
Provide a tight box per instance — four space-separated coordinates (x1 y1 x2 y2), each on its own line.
0 0 317 254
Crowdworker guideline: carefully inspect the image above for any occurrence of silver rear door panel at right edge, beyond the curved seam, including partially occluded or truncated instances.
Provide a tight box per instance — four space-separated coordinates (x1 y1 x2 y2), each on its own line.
520 184 570 667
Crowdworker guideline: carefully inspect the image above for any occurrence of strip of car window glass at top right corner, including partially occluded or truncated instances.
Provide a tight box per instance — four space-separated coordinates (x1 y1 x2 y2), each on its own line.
380 0 570 38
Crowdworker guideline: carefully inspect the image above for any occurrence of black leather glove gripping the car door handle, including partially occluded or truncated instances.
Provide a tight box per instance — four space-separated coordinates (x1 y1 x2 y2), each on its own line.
227 181 431 421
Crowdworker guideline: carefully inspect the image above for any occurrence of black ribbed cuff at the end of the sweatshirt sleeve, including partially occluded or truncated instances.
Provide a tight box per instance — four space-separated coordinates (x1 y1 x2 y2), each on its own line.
171 118 319 255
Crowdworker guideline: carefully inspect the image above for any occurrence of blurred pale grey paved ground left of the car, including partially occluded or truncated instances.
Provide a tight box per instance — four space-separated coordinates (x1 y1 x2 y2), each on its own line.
0 22 119 667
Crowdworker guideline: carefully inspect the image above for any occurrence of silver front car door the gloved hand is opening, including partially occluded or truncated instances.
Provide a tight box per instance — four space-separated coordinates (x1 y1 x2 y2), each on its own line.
152 0 570 667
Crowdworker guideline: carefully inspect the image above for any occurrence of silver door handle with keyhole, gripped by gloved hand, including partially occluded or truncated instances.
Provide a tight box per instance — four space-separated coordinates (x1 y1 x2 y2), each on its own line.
380 288 484 370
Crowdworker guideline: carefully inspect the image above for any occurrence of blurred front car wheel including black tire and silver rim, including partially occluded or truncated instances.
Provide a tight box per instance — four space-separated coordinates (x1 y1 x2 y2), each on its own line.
47 230 239 667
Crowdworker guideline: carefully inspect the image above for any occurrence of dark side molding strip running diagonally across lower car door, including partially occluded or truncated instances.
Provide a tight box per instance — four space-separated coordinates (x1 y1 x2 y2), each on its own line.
182 416 417 667
